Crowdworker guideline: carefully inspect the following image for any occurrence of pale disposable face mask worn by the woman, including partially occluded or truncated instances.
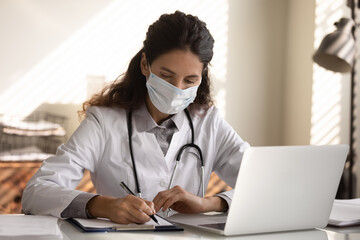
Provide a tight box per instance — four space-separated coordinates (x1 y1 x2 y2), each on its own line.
146 66 201 114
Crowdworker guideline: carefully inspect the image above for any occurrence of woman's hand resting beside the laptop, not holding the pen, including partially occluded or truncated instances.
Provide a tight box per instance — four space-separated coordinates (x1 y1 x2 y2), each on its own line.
153 186 227 213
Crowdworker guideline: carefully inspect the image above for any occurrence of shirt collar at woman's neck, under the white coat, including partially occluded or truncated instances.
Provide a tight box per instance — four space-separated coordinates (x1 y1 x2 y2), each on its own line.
134 103 186 132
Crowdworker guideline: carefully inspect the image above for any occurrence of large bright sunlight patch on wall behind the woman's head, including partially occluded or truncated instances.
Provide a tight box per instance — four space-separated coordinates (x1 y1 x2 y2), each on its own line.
0 0 228 116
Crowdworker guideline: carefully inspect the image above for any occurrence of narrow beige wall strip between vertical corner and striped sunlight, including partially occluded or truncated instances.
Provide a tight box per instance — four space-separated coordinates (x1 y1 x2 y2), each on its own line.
282 0 315 145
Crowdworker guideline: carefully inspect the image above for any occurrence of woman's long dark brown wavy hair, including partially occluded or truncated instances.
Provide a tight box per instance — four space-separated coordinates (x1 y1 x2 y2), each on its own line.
78 11 214 118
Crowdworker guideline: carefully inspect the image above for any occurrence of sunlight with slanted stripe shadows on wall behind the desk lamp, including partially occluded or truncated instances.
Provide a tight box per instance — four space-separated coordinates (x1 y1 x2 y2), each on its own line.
310 0 348 145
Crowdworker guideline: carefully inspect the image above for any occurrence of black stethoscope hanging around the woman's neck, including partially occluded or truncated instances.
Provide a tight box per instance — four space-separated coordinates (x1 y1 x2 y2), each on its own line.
127 109 205 198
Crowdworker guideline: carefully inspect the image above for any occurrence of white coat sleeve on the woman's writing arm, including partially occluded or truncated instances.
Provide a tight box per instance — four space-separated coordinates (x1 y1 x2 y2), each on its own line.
22 108 105 217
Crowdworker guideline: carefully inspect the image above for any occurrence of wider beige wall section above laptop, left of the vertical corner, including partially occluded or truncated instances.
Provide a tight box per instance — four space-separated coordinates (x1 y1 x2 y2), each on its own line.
226 0 288 145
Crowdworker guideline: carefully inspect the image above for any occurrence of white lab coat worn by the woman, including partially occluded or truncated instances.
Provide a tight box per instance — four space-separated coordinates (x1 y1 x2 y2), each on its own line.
22 106 249 217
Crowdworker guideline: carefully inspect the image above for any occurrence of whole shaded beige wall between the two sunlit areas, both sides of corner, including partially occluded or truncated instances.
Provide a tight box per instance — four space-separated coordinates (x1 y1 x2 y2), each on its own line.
226 0 315 145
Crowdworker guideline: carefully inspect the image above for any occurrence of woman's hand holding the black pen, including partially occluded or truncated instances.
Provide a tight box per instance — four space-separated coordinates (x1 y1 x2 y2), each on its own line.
86 195 156 224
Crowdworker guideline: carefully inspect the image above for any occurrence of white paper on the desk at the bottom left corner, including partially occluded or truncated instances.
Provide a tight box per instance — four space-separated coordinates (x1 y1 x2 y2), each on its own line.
0 214 62 238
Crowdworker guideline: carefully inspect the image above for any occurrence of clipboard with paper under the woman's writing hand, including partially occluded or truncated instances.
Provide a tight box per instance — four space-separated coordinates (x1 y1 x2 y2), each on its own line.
66 215 184 232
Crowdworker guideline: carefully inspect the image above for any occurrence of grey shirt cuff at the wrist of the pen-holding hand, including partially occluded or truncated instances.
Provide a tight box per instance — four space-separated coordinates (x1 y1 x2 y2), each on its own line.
61 192 97 218
